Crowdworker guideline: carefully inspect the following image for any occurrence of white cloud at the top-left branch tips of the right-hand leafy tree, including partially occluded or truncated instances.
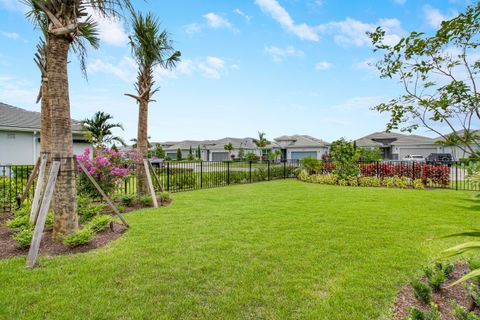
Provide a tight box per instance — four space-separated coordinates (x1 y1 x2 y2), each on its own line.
318 17 406 47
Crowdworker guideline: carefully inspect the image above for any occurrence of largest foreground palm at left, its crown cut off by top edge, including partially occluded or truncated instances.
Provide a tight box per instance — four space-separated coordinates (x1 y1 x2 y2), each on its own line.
24 0 131 238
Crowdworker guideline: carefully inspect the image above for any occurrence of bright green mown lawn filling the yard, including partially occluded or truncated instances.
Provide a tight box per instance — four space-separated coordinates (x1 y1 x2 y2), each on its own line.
0 180 479 319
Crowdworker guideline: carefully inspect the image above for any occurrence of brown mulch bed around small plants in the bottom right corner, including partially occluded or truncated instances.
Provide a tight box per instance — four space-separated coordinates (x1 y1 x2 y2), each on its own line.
393 262 480 320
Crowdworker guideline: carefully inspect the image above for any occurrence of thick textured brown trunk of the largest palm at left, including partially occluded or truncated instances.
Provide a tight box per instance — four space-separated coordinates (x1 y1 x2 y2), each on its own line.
47 35 78 239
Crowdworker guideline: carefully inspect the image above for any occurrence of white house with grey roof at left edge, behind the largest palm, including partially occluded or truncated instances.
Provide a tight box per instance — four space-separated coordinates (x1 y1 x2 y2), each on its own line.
0 103 90 165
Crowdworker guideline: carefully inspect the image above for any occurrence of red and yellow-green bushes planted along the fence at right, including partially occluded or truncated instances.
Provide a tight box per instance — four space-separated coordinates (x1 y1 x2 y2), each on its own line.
300 161 480 191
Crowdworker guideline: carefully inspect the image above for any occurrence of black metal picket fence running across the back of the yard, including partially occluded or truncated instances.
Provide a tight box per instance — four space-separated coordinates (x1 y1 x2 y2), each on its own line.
0 161 480 212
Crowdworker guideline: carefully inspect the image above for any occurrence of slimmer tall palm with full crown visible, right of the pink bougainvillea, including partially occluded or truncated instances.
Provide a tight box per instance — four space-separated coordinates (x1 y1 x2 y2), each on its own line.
126 12 181 195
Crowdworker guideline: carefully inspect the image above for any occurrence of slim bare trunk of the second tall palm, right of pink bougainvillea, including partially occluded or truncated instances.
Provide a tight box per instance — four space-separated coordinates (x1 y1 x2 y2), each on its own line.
137 99 148 196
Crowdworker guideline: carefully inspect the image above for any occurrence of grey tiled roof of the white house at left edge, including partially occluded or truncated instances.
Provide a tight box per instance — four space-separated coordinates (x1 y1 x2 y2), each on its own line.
0 102 82 132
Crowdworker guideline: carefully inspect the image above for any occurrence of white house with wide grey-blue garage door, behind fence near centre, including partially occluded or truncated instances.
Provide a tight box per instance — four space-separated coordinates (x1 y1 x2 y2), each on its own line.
271 135 329 161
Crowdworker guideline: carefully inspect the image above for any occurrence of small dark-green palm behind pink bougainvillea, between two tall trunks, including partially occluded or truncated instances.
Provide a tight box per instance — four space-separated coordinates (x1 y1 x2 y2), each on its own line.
82 111 125 147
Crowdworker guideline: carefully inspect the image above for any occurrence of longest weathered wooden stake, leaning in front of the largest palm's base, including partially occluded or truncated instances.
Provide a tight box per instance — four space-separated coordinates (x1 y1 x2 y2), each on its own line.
27 161 60 268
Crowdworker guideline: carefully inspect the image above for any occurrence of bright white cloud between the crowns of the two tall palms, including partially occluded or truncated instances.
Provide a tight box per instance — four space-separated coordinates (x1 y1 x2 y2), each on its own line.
87 9 128 46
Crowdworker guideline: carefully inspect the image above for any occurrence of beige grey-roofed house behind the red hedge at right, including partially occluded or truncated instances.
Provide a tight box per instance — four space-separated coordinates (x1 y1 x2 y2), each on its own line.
356 132 443 160
